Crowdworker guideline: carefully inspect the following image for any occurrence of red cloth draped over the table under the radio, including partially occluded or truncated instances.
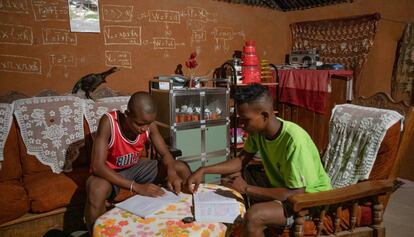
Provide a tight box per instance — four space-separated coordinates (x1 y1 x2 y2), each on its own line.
279 69 352 114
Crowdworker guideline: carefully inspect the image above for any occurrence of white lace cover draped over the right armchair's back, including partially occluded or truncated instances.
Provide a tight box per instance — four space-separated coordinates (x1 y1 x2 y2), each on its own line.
323 104 404 188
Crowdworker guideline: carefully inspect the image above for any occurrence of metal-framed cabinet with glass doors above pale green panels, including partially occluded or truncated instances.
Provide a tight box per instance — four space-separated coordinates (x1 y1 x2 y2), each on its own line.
150 80 230 183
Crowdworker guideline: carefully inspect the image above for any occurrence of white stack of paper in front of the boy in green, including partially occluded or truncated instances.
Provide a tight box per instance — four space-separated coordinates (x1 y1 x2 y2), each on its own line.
194 191 240 223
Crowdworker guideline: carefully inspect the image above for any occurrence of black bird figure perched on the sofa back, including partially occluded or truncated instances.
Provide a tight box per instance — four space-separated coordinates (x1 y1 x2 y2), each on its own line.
72 67 119 99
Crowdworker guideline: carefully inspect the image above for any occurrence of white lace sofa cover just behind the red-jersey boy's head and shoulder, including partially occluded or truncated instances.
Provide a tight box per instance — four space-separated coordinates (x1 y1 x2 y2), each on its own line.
85 96 130 134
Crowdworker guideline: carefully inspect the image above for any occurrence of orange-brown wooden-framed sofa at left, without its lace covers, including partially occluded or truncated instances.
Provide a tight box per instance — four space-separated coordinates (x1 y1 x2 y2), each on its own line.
0 88 133 237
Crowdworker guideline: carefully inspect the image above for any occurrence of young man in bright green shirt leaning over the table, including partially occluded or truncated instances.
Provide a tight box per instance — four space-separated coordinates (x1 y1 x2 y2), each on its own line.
187 84 331 236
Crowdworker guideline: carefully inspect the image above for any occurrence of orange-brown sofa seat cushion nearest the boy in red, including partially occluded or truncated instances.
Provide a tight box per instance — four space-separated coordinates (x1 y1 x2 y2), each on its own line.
23 169 87 213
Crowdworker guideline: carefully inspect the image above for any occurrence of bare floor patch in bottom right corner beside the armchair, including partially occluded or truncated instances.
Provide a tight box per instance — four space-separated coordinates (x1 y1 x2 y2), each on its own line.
384 179 414 237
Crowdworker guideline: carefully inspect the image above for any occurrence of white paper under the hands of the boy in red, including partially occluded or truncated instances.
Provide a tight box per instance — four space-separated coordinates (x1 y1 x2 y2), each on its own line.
115 189 181 218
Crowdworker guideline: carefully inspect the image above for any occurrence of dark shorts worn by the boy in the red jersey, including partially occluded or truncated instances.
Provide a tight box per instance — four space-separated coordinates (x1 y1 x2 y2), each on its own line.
108 158 158 200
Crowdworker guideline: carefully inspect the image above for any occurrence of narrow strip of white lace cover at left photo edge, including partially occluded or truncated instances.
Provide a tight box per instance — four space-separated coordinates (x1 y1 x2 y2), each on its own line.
0 103 13 165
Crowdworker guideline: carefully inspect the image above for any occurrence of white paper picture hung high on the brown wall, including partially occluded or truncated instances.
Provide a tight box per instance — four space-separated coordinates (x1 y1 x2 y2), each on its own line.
68 0 100 33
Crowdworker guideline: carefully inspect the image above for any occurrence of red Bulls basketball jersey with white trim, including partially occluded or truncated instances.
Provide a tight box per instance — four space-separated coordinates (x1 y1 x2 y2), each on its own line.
105 111 149 170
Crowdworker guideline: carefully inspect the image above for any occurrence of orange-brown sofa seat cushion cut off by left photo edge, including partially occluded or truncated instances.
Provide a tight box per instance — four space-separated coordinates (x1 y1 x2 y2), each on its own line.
0 181 29 224
